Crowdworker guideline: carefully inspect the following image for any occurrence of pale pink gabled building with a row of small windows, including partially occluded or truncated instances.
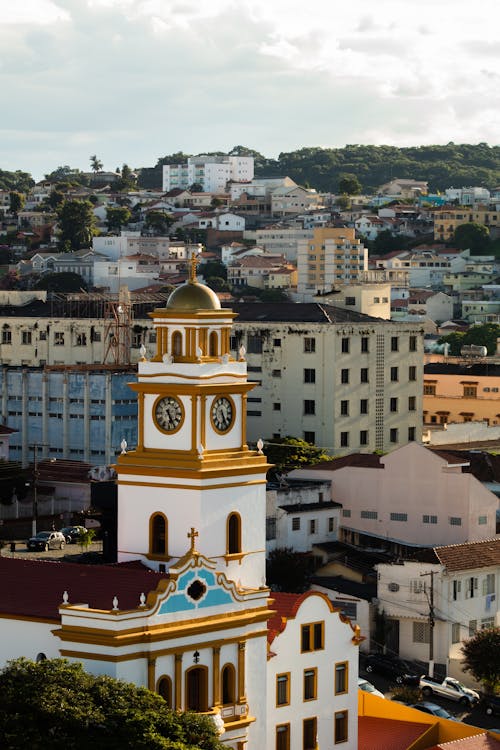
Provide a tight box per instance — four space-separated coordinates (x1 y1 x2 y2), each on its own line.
291 443 498 547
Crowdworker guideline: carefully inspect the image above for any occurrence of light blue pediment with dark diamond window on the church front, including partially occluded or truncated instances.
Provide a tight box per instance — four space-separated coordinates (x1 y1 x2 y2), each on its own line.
157 555 243 615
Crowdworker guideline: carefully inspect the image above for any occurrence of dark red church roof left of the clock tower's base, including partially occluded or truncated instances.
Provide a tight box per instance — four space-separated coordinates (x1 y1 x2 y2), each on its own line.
0 557 165 621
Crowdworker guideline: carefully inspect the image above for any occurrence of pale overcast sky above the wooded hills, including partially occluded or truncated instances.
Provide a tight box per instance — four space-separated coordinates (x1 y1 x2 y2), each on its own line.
0 0 500 179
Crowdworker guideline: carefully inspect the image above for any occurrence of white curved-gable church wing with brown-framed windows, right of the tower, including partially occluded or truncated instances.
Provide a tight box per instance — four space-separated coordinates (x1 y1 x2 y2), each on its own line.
266 592 359 750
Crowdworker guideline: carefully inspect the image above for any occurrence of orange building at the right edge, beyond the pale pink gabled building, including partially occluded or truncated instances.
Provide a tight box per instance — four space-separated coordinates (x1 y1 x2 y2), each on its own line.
423 358 500 425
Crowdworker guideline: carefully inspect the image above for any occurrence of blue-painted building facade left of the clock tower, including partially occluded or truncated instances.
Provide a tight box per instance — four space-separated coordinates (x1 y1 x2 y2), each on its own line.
0 366 137 465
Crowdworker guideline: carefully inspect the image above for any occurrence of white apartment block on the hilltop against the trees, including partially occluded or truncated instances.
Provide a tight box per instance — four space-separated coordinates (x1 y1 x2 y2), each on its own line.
163 155 254 193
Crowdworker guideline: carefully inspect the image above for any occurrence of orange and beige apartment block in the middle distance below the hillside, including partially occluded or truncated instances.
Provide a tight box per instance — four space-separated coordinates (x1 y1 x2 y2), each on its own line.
297 227 368 295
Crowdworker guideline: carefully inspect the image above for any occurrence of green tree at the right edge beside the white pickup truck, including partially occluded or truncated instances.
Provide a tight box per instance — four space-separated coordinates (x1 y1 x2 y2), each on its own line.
462 626 500 693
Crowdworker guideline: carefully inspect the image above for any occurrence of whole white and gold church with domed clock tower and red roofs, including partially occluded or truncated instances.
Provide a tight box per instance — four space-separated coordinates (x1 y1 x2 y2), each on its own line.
0 268 362 750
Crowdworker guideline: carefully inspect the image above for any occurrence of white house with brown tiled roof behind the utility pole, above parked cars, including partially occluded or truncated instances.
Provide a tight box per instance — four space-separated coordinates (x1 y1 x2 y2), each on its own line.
376 539 500 683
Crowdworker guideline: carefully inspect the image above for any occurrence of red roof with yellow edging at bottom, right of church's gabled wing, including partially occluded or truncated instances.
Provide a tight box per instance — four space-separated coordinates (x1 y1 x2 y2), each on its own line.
358 716 432 750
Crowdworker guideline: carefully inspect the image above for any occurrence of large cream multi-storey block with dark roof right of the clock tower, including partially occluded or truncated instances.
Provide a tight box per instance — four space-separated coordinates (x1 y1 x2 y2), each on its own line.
231 303 423 455
